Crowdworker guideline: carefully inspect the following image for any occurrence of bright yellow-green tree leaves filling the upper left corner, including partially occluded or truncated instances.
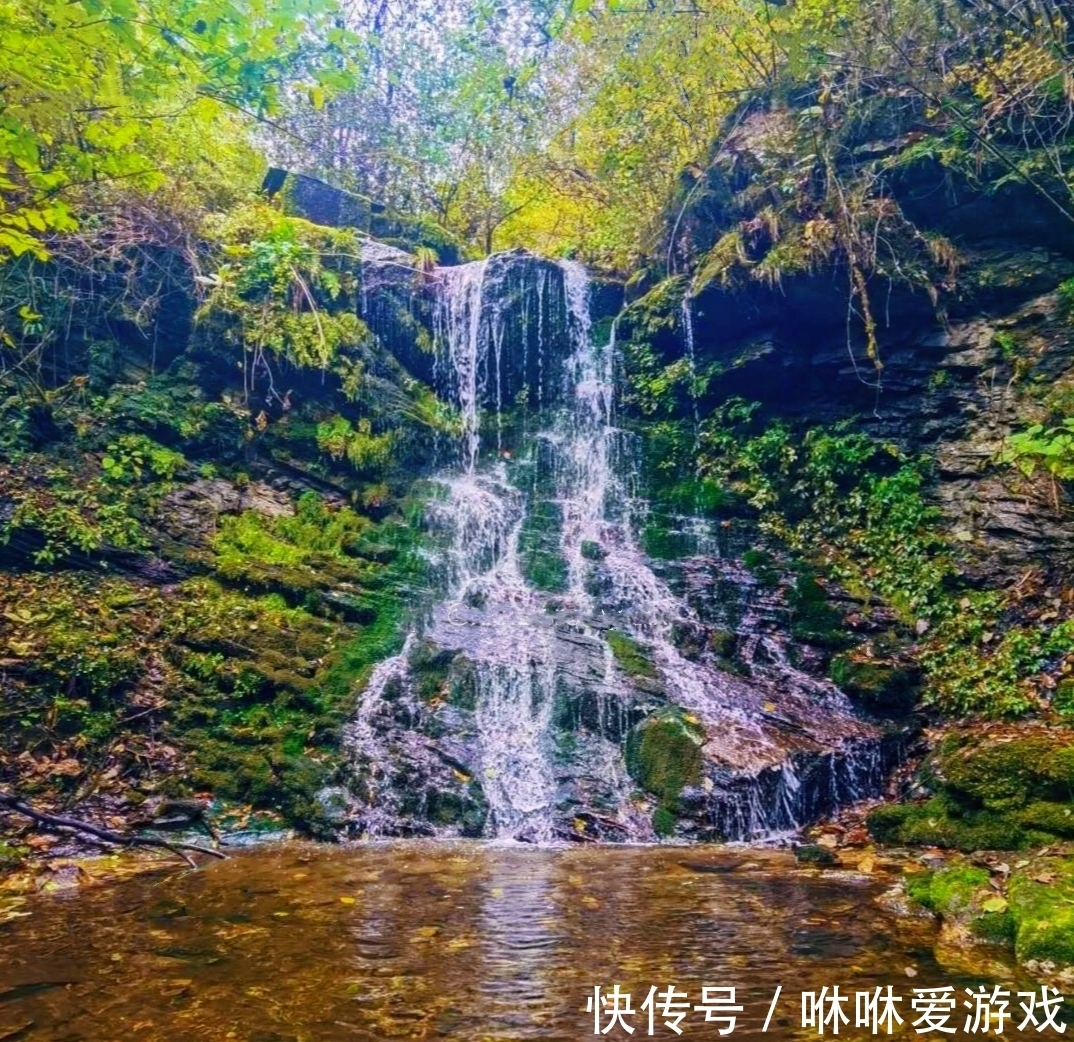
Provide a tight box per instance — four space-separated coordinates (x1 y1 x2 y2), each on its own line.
0 0 351 261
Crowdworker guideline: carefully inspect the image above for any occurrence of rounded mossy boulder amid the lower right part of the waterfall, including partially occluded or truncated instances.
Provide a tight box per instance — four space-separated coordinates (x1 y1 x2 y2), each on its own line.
626 707 706 811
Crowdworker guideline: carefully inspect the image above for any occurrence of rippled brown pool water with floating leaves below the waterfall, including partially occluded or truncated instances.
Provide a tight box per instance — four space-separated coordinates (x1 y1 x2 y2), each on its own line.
0 843 1056 1042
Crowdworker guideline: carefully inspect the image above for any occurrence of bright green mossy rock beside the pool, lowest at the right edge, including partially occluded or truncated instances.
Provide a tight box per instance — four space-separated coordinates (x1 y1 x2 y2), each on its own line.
1007 858 1074 969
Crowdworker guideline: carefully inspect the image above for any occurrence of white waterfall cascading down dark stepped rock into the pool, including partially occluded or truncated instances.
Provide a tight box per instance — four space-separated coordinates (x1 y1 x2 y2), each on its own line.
350 257 890 841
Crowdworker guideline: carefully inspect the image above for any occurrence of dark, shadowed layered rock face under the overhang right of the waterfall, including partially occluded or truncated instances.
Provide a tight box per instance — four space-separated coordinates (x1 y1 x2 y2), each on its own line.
666 164 1074 585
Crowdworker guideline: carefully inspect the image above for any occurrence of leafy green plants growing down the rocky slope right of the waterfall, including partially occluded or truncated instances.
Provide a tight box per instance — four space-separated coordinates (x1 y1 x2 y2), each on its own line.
627 369 1074 717
